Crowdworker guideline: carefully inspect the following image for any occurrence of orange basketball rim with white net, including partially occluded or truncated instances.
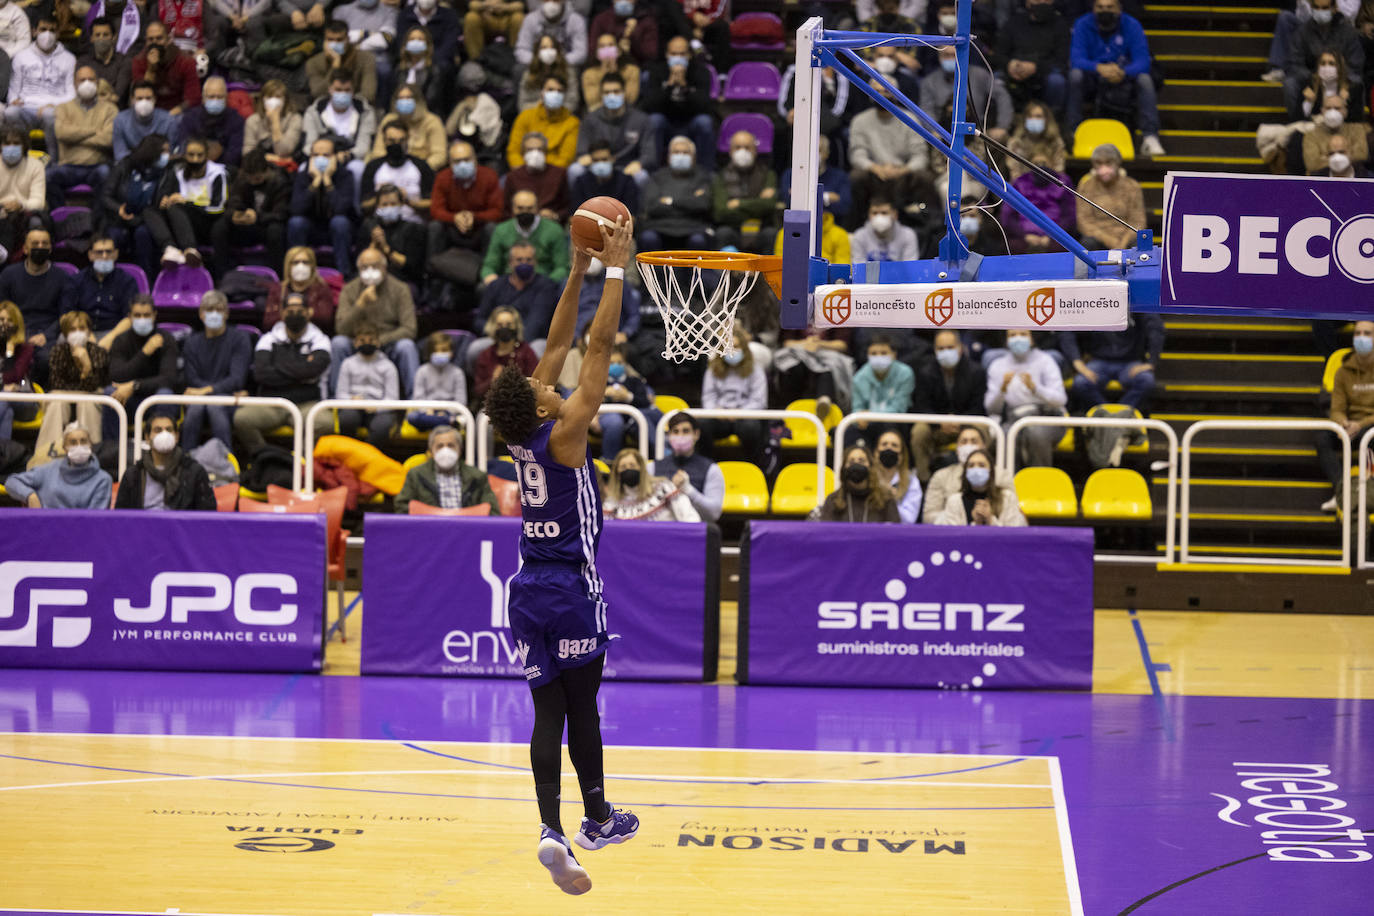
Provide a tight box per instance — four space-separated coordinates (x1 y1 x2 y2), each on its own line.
636 251 782 363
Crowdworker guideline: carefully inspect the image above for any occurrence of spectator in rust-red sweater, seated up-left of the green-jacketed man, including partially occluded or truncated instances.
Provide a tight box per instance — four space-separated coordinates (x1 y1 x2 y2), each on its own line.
429 140 502 300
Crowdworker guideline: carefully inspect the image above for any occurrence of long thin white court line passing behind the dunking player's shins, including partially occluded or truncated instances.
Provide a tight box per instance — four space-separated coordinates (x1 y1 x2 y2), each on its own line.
0 761 1051 791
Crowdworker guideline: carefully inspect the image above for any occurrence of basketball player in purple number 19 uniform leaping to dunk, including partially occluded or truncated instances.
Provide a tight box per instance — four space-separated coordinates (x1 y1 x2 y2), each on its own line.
486 217 639 894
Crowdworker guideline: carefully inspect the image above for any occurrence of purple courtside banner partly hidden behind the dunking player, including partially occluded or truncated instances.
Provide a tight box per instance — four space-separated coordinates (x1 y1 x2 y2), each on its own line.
363 515 720 681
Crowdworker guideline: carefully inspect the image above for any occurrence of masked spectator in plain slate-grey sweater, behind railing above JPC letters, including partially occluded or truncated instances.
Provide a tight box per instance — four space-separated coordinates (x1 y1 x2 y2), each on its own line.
181 290 253 452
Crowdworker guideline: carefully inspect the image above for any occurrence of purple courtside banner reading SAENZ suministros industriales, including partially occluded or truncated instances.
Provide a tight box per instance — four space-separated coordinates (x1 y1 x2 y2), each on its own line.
739 522 1092 689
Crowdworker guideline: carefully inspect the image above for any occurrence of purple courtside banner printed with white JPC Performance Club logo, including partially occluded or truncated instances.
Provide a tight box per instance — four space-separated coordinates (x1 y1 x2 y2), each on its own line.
0 509 324 672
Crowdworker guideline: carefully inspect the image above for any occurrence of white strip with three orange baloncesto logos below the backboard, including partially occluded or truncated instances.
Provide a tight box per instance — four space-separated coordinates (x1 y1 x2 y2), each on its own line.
812 280 1129 331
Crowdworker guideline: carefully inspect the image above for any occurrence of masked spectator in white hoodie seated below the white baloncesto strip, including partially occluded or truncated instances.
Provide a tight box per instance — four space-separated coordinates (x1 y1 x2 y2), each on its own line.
982 331 1069 467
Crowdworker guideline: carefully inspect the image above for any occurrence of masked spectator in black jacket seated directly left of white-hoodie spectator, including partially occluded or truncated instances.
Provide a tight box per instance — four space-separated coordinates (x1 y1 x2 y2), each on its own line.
911 331 988 486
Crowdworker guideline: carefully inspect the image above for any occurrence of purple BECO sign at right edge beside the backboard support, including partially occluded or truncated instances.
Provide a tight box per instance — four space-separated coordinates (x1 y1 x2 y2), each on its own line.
1160 172 1374 317
